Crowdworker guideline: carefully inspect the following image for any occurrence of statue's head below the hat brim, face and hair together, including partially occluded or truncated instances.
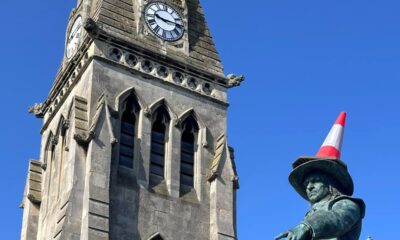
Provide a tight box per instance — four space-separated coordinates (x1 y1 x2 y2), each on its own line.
303 171 339 204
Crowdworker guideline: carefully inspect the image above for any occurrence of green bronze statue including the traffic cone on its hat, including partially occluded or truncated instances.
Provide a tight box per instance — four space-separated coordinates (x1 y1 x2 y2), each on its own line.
275 113 365 240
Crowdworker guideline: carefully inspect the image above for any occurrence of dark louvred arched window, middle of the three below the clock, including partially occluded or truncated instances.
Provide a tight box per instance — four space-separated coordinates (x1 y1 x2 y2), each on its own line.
150 106 170 185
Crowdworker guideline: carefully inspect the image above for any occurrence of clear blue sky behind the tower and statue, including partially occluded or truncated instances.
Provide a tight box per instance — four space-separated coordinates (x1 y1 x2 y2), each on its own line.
0 0 400 240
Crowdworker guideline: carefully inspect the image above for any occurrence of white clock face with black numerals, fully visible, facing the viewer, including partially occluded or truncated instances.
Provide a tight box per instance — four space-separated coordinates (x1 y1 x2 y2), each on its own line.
145 2 185 42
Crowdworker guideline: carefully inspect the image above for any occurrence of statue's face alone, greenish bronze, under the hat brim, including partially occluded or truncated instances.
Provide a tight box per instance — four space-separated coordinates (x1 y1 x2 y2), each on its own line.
304 173 330 203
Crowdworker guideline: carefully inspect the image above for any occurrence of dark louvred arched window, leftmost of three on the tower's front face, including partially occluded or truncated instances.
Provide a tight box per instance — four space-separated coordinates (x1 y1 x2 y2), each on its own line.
119 95 140 168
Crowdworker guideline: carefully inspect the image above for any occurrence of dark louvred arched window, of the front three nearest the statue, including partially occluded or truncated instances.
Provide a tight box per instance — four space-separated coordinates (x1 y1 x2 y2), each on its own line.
180 115 199 192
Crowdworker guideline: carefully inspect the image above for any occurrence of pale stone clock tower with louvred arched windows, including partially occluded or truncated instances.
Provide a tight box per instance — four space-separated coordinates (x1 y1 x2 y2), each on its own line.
21 0 243 240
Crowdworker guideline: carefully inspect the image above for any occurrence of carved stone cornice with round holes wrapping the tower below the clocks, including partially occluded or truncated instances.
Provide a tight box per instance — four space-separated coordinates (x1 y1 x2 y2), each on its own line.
39 19 244 131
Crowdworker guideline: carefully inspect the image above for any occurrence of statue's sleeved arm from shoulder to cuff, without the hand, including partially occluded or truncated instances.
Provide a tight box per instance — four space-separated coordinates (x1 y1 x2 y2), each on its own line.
304 199 361 239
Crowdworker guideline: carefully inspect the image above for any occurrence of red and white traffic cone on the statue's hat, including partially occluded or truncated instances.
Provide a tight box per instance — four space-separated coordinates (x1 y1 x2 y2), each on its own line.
316 112 346 159
